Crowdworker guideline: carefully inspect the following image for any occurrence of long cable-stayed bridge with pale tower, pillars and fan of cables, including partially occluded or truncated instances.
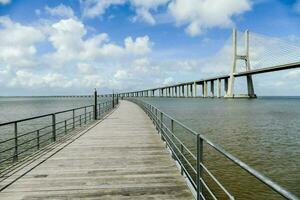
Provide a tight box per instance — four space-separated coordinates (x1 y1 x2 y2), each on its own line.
120 29 300 98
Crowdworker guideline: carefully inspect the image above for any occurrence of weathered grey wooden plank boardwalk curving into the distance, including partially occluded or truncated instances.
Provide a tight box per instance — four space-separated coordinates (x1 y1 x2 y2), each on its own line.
0 101 194 200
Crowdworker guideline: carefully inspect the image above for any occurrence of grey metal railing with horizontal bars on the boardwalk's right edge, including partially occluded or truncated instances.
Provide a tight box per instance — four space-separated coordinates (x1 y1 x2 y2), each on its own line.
128 98 299 200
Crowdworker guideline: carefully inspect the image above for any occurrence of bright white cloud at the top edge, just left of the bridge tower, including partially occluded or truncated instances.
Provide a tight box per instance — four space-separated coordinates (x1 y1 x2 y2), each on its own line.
169 0 251 36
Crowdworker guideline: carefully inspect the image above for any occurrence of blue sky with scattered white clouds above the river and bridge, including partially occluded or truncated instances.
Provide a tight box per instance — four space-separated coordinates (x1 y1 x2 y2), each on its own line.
0 0 300 96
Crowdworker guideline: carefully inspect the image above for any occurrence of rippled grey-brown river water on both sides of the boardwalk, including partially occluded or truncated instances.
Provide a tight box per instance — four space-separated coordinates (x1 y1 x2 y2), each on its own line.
0 97 300 199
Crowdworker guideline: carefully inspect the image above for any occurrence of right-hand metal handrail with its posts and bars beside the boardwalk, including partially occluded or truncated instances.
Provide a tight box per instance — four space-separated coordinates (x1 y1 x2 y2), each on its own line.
127 98 299 200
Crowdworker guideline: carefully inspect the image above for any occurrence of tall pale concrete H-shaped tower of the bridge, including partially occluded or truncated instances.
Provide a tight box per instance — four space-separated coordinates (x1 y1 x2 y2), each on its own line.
225 28 256 98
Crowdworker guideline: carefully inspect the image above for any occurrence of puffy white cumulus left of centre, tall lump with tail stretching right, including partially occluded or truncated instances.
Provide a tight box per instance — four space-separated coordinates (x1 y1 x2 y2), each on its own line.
48 18 152 65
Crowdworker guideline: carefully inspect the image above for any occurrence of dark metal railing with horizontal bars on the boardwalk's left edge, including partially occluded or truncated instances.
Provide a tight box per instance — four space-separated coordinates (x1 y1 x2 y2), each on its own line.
0 98 118 174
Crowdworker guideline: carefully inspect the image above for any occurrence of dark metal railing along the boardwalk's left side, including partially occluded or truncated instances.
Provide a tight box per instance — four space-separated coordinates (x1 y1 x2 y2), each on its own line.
0 97 119 174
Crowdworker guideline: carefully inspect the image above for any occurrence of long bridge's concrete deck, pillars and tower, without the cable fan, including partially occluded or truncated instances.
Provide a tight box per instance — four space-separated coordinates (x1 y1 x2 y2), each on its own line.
119 29 300 98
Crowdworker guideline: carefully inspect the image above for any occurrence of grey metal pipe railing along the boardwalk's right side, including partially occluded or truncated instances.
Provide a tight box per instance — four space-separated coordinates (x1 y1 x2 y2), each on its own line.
128 98 299 200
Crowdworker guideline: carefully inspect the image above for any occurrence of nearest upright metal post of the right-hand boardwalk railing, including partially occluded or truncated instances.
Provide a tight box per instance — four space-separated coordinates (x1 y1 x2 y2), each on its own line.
196 134 203 200
